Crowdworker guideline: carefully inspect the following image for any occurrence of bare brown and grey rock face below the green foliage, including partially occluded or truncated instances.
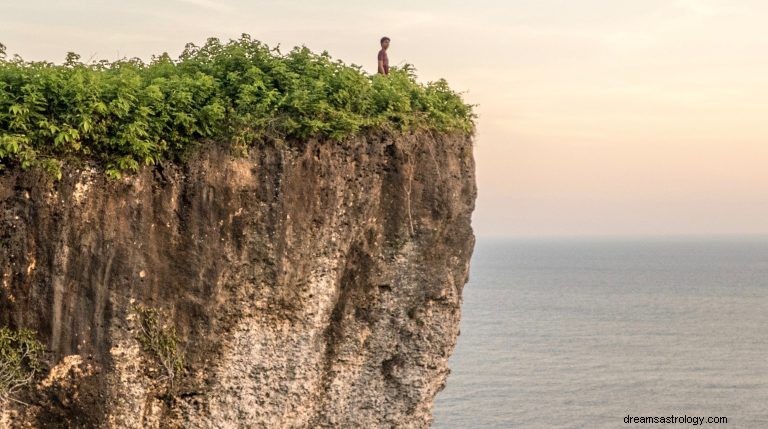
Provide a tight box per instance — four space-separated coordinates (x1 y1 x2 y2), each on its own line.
0 134 476 428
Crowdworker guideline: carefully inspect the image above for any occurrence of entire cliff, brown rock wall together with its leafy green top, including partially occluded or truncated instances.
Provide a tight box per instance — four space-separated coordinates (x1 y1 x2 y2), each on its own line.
0 35 476 428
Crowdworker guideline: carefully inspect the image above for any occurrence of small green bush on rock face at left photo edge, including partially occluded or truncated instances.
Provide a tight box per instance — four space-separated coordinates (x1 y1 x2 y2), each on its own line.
0 327 45 402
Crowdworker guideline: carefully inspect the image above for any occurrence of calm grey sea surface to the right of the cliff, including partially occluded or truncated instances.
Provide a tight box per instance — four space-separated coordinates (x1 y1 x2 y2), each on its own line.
434 239 768 429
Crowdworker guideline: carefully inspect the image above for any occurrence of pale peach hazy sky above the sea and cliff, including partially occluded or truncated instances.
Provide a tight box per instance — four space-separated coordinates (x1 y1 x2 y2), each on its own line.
0 0 768 236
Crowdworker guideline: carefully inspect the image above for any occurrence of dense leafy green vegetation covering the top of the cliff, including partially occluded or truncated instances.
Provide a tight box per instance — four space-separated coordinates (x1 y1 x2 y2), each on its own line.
0 35 475 176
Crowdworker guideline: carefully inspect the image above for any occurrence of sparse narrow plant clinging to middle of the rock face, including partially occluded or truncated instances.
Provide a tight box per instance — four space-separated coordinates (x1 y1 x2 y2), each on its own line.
133 305 184 381
